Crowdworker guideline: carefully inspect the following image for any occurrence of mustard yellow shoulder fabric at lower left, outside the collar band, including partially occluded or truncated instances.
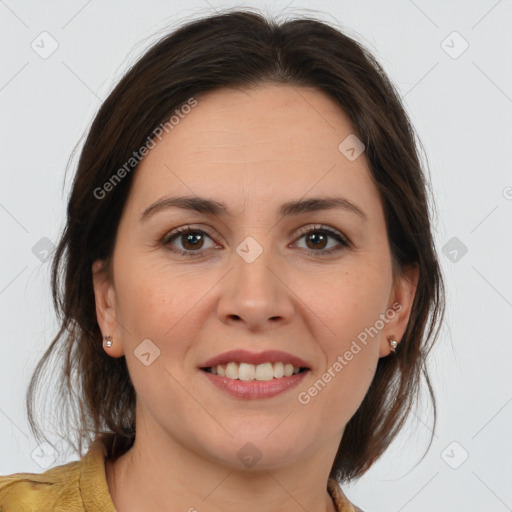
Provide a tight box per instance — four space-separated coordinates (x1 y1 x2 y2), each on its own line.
0 461 83 512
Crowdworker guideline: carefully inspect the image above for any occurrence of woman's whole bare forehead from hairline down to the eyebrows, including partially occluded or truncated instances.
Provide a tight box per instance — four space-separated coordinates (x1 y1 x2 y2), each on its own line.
126 84 378 220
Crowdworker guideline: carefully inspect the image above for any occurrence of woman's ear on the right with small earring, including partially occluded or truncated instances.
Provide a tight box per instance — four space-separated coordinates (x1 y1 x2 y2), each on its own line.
379 264 420 357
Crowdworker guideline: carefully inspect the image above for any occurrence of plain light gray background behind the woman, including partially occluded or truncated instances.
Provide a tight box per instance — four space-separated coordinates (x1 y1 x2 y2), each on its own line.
0 0 512 512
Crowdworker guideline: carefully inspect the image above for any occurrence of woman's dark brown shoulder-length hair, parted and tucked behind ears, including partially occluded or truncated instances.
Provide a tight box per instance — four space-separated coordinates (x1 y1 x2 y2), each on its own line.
26 6 445 481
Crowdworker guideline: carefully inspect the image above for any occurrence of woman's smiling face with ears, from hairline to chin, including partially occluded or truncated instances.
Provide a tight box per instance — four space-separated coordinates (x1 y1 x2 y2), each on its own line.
94 84 417 468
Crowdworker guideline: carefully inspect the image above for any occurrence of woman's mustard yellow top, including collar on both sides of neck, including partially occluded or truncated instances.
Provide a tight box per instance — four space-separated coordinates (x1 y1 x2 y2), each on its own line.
0 439 363 512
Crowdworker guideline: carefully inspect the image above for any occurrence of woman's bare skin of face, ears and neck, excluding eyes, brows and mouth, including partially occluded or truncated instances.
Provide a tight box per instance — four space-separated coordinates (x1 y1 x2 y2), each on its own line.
92 84 418 512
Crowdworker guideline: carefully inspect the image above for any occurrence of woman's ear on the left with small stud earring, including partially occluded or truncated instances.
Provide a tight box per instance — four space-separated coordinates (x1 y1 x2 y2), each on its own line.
92 260 124 357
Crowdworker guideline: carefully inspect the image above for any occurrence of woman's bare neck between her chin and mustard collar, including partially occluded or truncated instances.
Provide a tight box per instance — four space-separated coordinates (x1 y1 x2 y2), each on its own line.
106 431 339 512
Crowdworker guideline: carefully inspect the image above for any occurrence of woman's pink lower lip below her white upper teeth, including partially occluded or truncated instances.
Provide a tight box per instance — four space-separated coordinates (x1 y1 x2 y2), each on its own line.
199 370 309 399
